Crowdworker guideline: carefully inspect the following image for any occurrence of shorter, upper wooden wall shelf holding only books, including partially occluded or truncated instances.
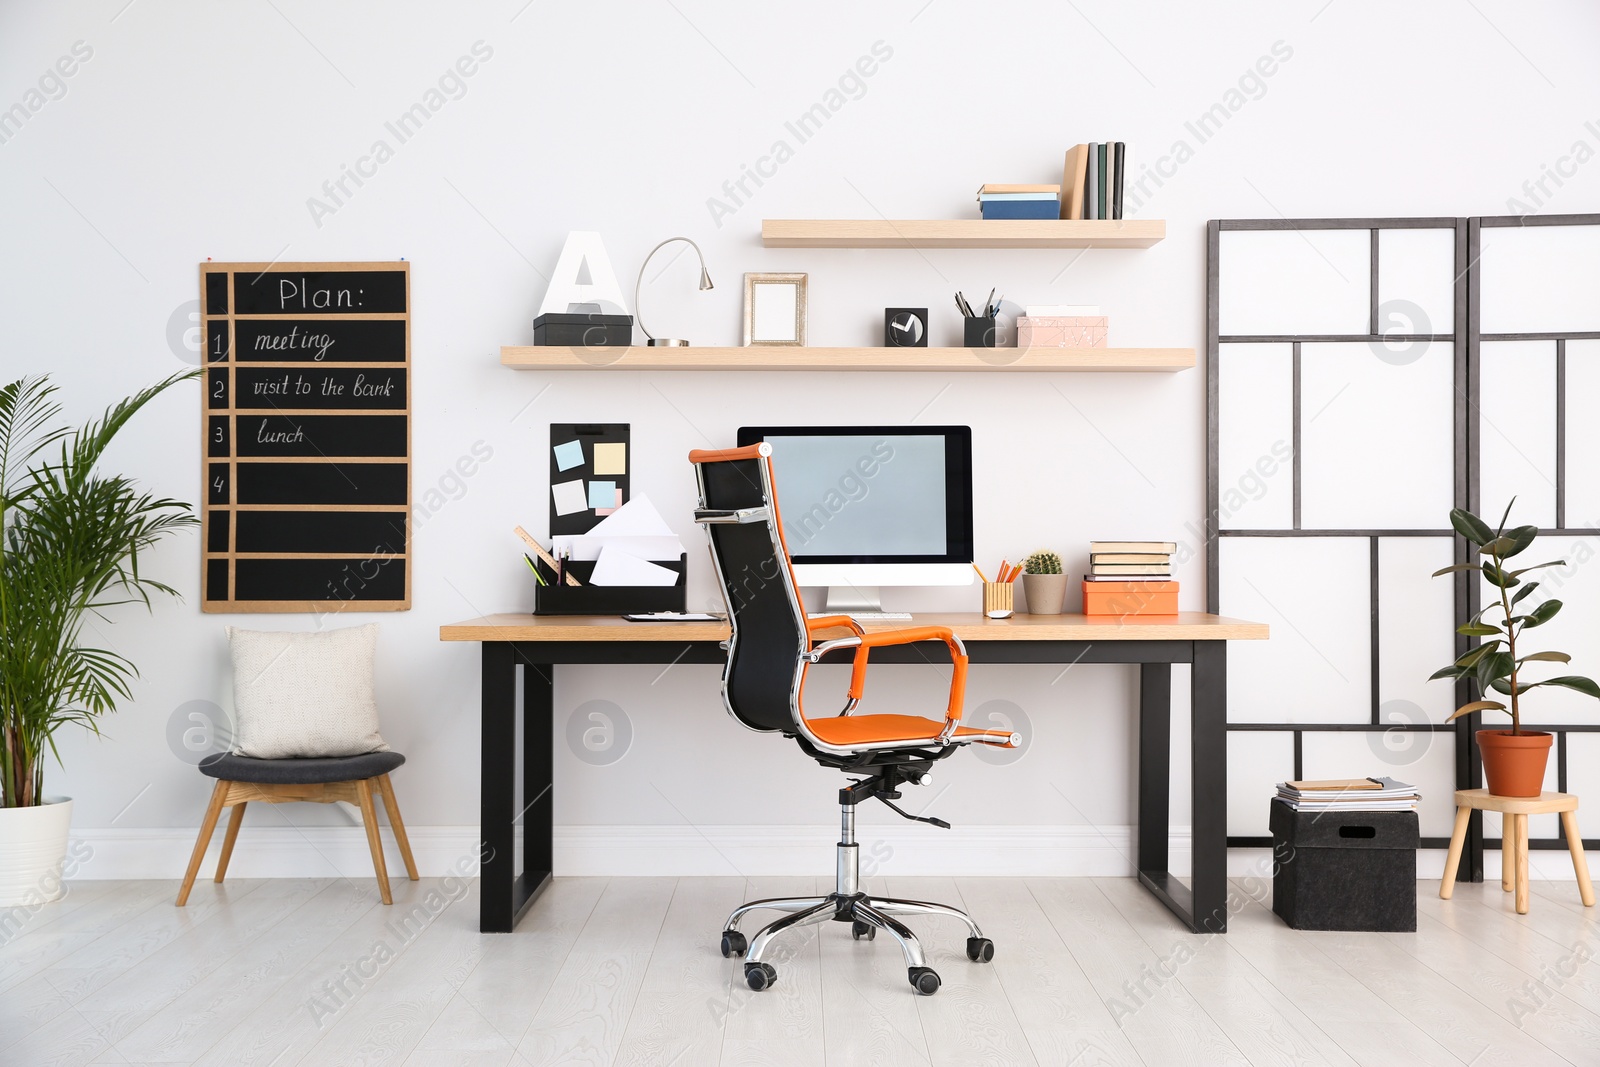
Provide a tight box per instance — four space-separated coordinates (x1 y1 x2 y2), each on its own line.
762 219 1166 248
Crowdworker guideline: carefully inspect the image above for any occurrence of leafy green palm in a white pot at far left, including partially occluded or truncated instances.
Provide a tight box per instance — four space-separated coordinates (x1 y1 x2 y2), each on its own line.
0 371 197 905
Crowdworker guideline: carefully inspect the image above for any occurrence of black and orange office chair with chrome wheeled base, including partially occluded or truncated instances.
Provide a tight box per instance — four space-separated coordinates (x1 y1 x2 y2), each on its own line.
690 442 1022 997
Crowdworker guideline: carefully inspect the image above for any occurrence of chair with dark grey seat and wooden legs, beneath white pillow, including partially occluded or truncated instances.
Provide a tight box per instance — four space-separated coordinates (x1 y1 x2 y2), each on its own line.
178 752 416 907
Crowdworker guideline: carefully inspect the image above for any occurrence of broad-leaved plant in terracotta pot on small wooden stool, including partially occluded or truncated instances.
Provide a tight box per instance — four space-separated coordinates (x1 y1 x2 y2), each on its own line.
1430 501 1600 797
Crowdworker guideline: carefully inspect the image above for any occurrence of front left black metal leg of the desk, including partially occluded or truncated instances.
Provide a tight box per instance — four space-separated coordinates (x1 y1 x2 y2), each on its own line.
478 641 517 934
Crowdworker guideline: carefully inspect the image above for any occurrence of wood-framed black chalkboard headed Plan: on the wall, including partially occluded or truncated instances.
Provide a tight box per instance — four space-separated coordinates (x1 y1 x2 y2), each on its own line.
200 261 414 613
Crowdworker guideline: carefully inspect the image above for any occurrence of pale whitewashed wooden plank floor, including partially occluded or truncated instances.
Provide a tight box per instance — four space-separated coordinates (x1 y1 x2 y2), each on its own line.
0 878 1600 1067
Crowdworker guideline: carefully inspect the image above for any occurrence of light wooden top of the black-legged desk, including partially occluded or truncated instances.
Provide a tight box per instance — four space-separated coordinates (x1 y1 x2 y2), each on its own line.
438 611 1267 641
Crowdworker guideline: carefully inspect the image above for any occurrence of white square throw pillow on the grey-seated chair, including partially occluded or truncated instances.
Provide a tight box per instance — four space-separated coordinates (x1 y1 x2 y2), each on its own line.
227 622 389 760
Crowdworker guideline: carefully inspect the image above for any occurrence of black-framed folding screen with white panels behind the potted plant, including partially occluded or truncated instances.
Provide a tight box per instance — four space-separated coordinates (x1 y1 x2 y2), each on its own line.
1206 216 1600 878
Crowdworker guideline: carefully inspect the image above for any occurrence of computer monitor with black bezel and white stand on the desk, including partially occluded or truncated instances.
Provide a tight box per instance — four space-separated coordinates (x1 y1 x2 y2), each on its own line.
739 426 974 613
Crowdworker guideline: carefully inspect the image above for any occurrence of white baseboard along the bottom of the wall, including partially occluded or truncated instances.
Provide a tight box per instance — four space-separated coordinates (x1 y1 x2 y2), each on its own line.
69 825 1573 880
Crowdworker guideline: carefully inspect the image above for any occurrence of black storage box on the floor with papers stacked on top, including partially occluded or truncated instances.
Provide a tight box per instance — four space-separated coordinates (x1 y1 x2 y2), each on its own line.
1269 800 1421 933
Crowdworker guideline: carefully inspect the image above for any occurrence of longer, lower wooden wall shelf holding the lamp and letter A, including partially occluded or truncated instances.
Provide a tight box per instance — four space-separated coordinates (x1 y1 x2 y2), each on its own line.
501 346 1195 373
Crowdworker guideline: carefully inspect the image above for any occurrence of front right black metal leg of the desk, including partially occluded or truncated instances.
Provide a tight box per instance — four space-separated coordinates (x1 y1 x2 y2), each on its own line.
1189 641 1227 934
